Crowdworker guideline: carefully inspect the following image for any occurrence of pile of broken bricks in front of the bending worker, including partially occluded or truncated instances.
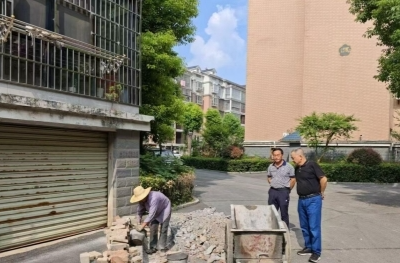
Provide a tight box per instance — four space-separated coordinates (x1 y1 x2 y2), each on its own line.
80 216 143 263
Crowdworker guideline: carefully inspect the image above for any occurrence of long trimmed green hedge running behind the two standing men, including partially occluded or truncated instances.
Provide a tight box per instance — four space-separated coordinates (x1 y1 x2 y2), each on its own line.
182 157 400 183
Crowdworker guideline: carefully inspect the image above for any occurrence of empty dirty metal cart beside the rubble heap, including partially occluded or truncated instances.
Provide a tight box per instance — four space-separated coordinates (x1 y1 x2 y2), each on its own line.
225 205 291 263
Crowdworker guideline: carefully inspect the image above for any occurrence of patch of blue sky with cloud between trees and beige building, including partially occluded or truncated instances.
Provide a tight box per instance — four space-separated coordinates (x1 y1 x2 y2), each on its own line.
175 0 247 84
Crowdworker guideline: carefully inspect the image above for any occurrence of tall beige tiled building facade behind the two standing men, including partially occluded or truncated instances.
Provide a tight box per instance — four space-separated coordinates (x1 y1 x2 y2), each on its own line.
245 0 400 160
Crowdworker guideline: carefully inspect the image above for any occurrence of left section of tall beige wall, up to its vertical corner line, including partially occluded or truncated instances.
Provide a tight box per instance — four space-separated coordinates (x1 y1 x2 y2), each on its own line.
245 0 305 141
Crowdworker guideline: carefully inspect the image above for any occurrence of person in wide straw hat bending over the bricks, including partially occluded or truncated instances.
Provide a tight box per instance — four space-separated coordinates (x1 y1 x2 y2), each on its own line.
131 186 171 254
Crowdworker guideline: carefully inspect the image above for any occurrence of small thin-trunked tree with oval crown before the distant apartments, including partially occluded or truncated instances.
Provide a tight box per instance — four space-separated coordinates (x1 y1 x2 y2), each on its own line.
182 102 204 155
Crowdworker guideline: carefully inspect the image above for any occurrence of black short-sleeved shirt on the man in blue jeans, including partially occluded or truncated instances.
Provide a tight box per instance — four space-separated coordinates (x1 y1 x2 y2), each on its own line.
295 161 325 195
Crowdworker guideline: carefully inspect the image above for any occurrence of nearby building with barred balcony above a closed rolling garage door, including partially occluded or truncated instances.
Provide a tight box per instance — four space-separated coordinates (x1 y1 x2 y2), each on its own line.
0 0 153 252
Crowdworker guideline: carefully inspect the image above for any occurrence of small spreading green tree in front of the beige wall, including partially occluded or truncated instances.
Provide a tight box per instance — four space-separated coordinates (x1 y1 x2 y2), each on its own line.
296 112 358 162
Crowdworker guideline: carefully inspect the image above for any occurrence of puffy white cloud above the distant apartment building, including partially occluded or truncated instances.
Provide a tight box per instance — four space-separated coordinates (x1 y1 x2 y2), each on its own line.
189 6 245 69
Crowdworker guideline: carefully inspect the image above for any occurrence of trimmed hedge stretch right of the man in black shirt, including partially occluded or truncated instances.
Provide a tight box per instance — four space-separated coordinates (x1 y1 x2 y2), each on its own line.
320 163 400 183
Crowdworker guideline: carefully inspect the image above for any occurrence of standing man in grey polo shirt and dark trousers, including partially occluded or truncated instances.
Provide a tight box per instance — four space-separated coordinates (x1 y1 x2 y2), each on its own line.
267 148 296 228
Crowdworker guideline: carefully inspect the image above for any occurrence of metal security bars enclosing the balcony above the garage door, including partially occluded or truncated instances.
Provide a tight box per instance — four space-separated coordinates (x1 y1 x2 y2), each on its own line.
0 0 141 105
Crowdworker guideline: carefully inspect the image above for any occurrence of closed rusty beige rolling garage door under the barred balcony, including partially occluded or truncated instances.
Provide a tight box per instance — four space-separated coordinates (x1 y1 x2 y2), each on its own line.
0 124 108 251
